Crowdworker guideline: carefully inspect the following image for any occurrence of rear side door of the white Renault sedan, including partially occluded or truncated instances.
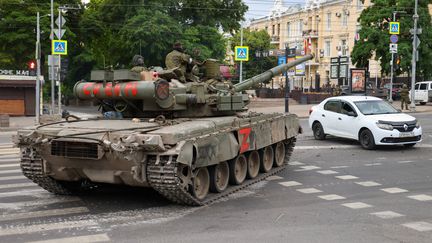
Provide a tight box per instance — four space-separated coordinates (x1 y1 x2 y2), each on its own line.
321 99 341 136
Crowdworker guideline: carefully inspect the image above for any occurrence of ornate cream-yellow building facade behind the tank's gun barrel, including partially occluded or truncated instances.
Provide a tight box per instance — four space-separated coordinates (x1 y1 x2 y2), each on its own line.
249 0 380 90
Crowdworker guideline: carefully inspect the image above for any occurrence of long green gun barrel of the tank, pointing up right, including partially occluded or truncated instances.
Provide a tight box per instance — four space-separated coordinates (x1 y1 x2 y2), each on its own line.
234 54 314 92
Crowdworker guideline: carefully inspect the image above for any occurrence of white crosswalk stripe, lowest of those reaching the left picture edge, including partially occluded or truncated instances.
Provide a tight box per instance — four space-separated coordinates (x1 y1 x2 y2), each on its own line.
0 220 97 236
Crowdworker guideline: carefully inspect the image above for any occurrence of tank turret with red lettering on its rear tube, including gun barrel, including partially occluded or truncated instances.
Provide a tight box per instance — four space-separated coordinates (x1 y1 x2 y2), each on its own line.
74 55 313 118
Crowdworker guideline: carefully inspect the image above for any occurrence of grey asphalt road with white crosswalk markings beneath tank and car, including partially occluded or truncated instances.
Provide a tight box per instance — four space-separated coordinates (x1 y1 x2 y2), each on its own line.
0 114 432 242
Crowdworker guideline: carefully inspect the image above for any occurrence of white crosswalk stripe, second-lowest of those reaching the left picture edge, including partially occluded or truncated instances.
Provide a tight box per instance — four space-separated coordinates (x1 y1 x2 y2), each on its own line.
0 207 89 221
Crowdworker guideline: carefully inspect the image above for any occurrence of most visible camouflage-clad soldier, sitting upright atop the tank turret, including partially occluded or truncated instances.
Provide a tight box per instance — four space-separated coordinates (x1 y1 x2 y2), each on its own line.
165 42 198 82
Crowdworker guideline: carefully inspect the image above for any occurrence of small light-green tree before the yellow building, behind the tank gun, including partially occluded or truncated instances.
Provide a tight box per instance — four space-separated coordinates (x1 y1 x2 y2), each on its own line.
232 29 277 78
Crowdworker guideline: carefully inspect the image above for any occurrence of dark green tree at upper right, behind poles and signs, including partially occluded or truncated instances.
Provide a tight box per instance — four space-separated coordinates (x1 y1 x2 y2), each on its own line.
351 0 432 78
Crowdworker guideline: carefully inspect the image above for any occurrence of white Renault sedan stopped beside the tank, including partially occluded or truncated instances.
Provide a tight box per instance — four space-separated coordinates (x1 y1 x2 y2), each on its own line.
309 96 422 149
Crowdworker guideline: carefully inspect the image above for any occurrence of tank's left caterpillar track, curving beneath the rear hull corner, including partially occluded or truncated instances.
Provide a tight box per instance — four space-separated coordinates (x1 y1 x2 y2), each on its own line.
20 151 73 195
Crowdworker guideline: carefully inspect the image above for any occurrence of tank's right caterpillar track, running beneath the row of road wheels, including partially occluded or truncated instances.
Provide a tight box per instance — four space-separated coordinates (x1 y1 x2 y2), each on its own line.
147 138 296 206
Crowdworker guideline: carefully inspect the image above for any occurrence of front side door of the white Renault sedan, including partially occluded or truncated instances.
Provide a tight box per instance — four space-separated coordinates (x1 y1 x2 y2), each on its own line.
336 101 358 139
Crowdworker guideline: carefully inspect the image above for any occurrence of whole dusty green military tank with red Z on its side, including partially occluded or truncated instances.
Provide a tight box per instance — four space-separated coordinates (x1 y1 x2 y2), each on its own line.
15 55 313 205
